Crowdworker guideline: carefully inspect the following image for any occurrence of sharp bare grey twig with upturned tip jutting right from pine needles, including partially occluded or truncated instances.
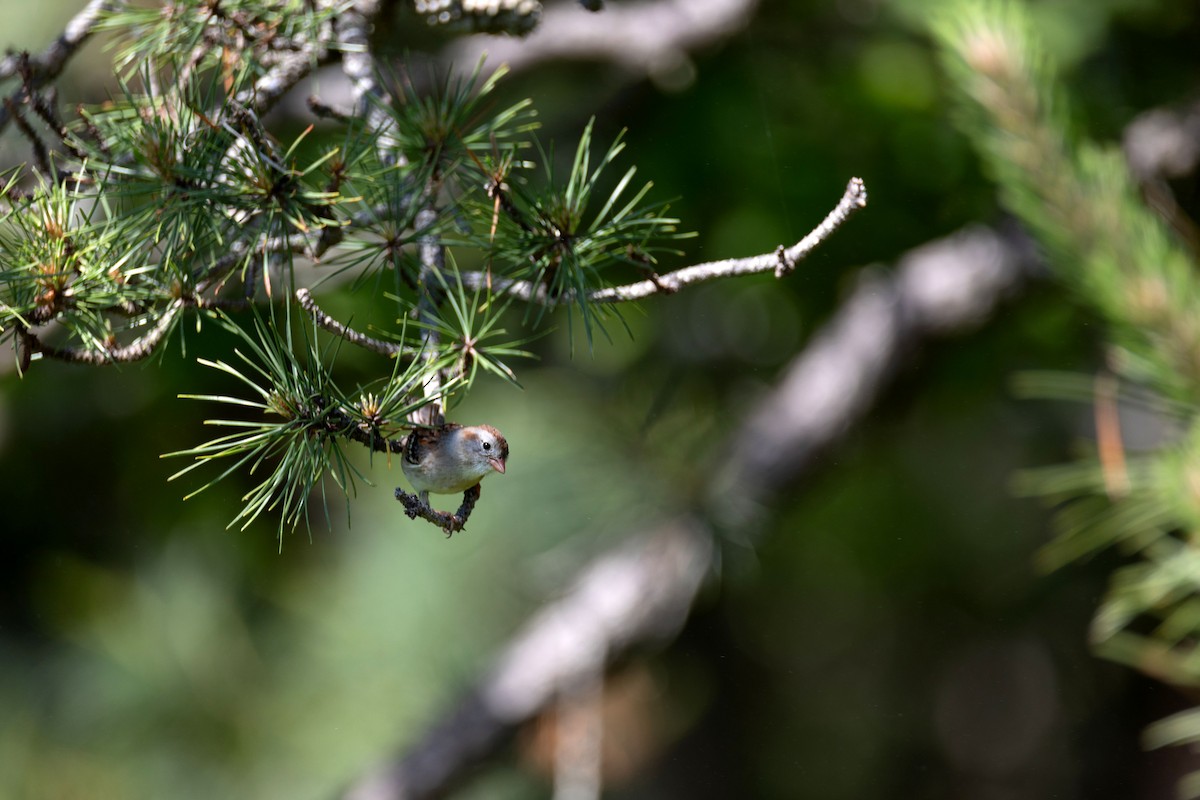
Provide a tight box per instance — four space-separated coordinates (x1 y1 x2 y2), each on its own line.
461 178 866 306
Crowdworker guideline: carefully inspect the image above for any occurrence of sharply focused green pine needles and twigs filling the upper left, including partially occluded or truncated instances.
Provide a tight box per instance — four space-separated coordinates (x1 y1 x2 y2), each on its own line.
0 0 865 535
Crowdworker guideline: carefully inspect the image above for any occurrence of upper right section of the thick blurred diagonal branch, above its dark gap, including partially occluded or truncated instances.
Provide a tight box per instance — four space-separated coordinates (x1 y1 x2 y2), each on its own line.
710 225 1038 525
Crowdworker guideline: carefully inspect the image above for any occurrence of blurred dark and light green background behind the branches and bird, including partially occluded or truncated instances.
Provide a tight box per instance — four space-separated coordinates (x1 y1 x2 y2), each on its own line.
7 0 1200 800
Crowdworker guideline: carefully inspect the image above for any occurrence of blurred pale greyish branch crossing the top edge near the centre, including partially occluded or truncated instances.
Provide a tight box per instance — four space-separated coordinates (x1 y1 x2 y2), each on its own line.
446 0 758 78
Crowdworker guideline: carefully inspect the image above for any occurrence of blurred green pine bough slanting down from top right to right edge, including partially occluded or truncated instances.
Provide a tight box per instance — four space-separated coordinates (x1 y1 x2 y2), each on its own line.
935 2 1200 397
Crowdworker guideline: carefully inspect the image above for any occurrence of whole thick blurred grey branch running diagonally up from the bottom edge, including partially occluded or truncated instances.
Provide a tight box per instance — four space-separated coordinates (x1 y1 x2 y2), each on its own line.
346 220 1036 800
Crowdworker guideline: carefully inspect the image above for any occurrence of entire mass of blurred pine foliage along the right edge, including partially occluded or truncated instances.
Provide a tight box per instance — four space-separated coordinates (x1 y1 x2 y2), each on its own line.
934 1 1200 796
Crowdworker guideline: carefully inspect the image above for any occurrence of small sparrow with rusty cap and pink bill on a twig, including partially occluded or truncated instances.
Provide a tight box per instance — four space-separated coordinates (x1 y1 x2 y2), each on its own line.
401 422 509 505
